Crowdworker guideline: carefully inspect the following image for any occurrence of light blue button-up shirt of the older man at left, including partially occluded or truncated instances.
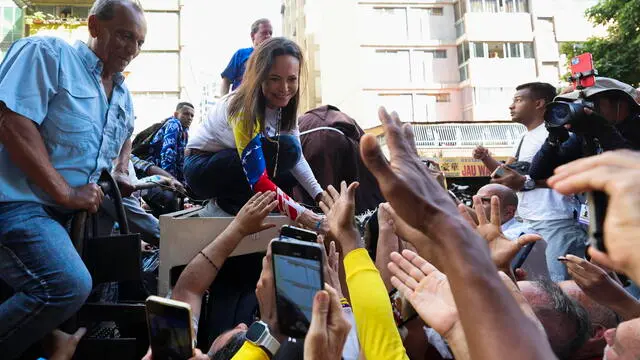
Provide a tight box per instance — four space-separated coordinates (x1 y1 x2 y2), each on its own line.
0 37 134 205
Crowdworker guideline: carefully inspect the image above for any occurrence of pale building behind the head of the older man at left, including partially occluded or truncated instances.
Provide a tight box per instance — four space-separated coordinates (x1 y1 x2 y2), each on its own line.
8 0 183 131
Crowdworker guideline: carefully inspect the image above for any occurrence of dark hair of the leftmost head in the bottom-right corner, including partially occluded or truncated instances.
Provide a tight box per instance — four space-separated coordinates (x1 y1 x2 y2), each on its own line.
534 280 591 359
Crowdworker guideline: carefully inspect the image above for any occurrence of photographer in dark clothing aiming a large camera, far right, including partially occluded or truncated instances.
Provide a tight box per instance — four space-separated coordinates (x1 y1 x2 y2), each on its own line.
529 77 640 180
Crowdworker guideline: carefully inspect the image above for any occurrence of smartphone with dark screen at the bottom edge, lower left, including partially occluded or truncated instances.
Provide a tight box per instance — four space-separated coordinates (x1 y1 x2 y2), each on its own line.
145 296 195 360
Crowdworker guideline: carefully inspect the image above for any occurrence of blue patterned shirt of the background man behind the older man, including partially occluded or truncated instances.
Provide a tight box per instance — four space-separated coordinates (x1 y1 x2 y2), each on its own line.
147 117 189 182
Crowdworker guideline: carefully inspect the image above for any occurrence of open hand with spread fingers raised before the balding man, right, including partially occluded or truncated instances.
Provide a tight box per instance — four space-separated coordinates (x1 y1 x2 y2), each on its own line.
458 195 542 275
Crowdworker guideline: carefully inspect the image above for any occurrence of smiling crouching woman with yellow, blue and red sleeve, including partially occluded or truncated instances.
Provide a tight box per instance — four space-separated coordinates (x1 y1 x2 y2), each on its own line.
184 38 327 233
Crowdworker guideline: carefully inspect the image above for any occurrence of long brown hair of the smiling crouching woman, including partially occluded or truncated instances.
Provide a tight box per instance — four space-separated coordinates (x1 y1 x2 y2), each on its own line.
228 37 304 134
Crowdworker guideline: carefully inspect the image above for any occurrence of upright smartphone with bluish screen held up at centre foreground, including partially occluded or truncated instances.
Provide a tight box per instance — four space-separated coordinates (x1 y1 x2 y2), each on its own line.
272 239 324 338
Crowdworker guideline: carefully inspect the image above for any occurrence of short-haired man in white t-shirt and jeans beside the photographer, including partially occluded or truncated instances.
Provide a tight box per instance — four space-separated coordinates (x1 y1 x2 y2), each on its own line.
473 82 587 282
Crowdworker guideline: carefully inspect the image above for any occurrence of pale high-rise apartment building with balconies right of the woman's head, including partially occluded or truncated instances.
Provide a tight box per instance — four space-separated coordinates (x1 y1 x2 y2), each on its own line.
281 0 602 176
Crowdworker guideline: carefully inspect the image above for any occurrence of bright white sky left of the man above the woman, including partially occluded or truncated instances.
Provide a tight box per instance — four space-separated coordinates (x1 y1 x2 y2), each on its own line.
181 0 282 102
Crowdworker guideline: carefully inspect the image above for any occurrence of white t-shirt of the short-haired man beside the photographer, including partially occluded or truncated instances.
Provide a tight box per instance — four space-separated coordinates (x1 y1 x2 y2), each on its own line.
513 123 578 220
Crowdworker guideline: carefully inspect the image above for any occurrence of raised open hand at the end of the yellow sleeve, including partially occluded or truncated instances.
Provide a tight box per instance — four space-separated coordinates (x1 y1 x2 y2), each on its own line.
320 181 360 256
